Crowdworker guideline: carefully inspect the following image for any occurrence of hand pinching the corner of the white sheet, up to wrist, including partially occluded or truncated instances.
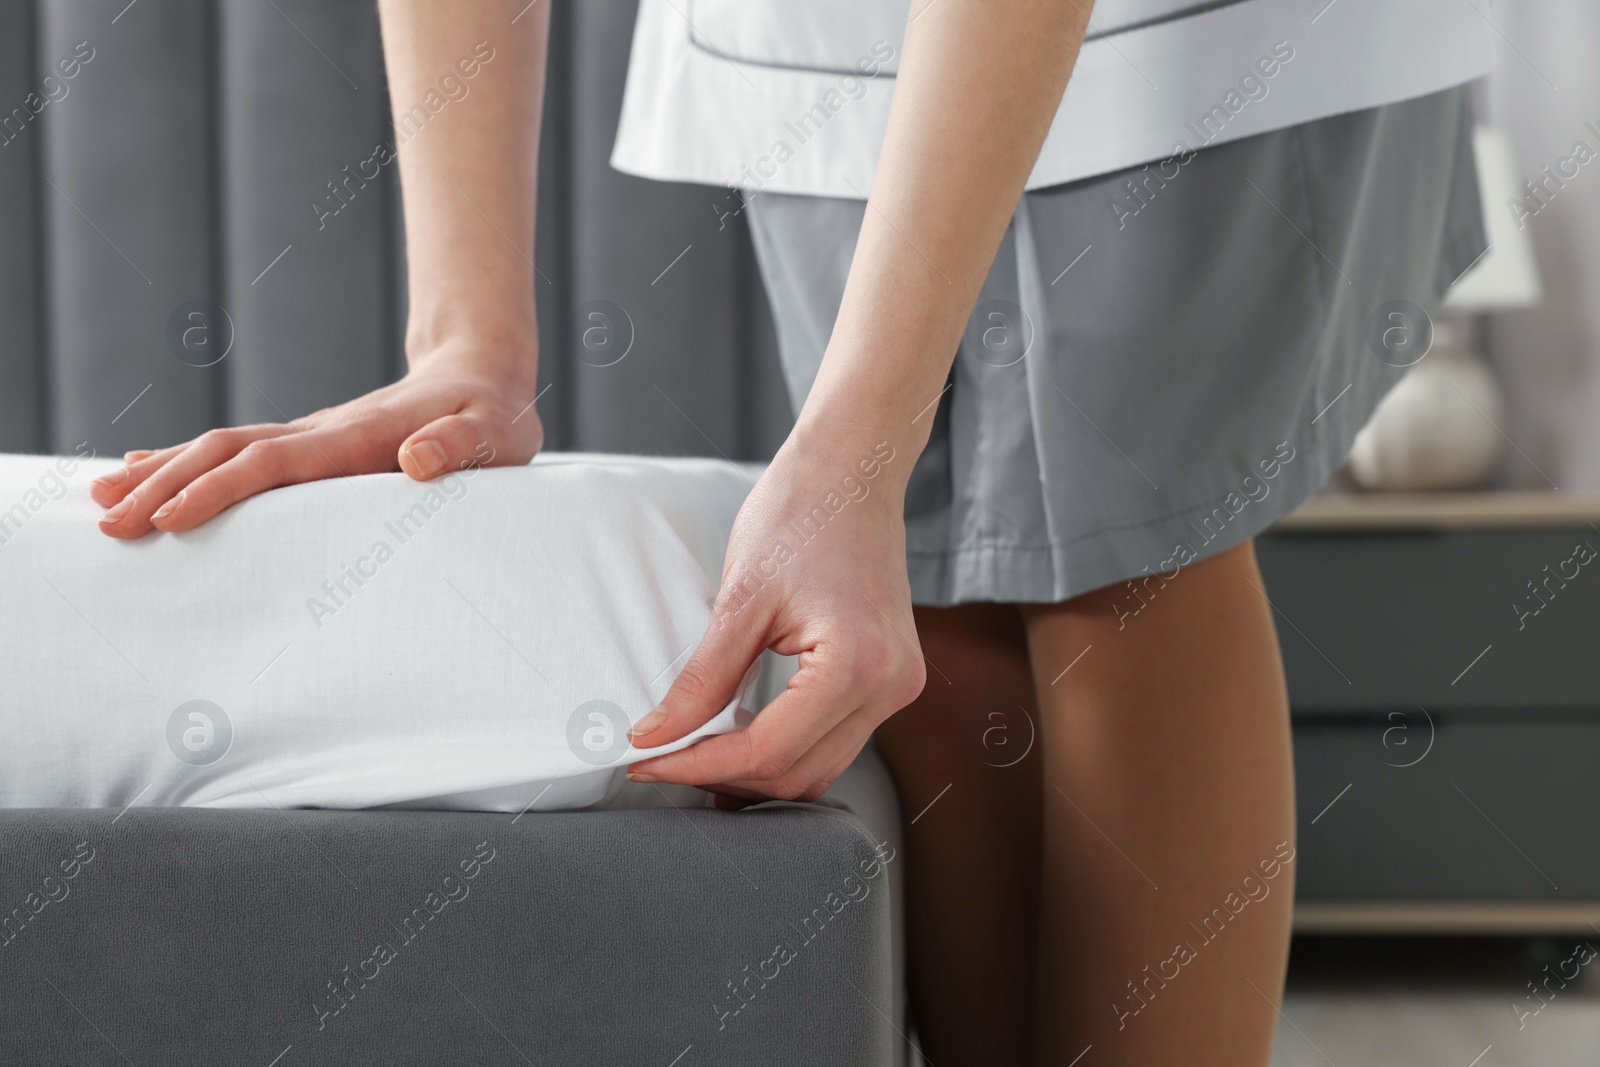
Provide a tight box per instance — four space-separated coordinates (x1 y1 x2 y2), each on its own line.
629 438 925 800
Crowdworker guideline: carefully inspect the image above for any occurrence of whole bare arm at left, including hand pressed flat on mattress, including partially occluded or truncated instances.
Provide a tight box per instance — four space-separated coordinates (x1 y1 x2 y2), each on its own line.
90 0 550 539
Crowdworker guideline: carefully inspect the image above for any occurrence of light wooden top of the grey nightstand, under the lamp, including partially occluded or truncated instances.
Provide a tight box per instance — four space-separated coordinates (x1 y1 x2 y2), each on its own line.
1272 491 1600 534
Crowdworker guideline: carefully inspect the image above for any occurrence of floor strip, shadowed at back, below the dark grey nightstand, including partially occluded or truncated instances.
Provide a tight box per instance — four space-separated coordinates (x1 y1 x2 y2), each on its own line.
1272 934 1600 1067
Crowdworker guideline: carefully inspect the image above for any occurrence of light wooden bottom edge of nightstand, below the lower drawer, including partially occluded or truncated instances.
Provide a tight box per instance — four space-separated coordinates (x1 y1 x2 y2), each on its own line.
1294 901 1600 936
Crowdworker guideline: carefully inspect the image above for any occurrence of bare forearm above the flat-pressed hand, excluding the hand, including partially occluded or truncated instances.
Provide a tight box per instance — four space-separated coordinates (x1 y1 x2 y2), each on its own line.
379 0 550 381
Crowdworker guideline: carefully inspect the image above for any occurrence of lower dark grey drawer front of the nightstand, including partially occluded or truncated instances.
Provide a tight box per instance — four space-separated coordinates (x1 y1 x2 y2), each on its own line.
1294 710 1600 902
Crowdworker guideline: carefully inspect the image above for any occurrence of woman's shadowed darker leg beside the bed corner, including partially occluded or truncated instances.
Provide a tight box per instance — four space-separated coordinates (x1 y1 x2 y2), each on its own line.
877 603 1043 1067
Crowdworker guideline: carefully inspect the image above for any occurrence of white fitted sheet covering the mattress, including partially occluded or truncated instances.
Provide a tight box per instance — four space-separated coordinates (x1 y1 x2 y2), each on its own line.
0 454 786 811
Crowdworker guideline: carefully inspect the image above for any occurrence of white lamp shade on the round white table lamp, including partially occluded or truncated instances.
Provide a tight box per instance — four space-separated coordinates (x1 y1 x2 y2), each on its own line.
1443 126 1544 314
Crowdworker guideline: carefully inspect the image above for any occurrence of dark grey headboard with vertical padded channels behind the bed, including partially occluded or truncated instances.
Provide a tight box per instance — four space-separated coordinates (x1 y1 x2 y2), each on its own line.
0 0 790 459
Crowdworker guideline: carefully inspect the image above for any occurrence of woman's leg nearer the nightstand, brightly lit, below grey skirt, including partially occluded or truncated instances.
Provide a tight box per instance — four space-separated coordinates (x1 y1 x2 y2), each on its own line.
1024 544 1294 1067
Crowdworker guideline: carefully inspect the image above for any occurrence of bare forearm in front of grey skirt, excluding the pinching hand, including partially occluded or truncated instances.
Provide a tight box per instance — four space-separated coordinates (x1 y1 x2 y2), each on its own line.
792 0 1091 475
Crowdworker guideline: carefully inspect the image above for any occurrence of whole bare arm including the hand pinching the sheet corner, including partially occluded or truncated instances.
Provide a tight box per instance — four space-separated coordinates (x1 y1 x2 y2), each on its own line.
630 0 1090 800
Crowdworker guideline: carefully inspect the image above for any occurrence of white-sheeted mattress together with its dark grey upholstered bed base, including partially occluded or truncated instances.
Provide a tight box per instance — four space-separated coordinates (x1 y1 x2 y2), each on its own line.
0 456 909 1067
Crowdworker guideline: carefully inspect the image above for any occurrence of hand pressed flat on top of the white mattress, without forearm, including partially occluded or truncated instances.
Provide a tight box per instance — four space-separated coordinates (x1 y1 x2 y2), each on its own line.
90 344 544 539
